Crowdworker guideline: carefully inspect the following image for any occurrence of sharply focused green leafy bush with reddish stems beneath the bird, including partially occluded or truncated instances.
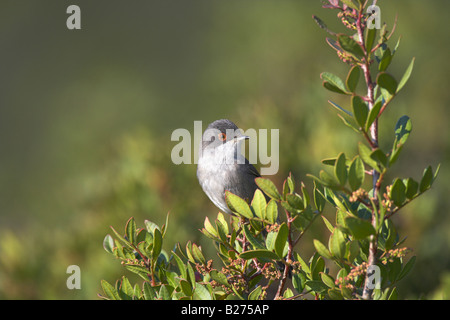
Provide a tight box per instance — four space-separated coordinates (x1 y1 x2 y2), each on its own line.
101 0 439 300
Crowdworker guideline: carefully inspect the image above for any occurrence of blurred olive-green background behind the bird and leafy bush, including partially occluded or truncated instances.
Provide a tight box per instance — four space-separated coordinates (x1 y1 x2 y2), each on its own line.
0 0 450 299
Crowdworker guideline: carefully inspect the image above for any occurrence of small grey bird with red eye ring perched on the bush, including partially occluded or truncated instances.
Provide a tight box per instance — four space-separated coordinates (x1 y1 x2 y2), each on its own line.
197 119 261 215
